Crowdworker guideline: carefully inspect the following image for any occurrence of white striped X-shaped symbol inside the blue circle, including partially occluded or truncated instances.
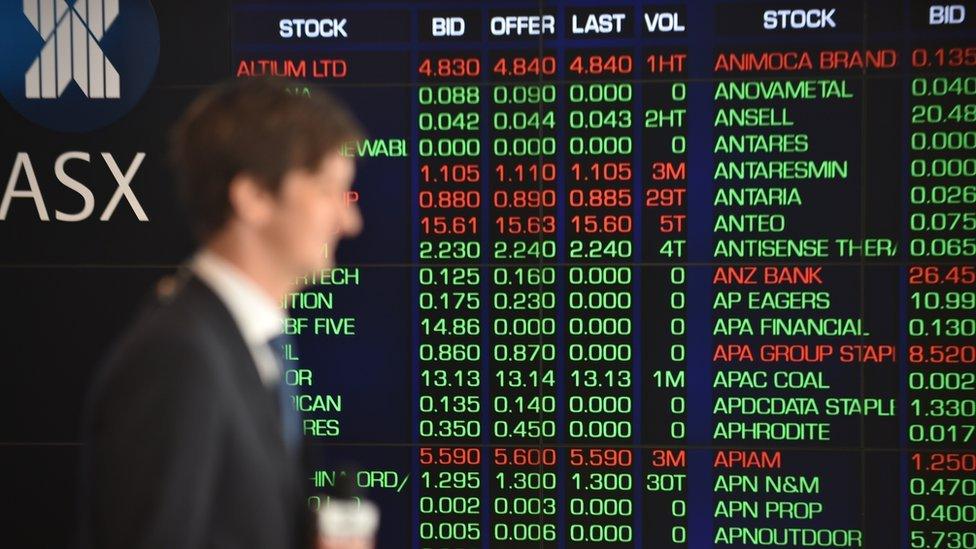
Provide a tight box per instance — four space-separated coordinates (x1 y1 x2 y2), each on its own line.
24 0 120 99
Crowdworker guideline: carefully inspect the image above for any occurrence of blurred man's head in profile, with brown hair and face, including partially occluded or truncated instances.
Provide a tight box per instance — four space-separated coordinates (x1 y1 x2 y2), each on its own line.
172 79 362 274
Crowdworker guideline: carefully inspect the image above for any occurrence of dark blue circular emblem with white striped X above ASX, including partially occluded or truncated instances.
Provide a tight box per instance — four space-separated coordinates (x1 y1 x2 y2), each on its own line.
0 0 159 132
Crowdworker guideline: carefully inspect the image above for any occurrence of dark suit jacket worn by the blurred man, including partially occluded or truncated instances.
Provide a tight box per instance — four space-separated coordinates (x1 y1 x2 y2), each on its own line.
81 270 314 549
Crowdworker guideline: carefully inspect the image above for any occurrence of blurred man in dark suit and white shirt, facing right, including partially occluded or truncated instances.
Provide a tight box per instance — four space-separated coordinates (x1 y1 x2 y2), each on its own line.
81 80 361 549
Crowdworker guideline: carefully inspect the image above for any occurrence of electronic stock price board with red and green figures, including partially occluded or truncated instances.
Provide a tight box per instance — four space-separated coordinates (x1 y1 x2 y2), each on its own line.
233 0 976 549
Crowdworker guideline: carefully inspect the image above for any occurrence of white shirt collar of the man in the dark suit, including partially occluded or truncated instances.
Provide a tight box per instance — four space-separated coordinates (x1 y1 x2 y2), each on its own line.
190 249 285 387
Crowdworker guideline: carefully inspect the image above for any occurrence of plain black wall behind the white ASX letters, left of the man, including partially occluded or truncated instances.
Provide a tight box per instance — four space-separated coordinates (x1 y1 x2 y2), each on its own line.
0 0 231 548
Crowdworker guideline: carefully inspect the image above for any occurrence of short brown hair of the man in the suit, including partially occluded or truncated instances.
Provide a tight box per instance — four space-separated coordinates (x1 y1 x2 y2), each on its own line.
170 78 363 239
